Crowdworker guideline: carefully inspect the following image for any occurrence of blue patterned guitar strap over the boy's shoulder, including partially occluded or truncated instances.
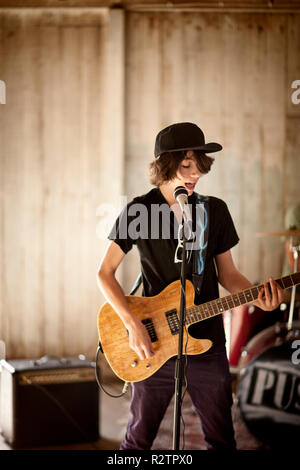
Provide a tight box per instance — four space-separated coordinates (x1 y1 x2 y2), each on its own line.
192 194 209 295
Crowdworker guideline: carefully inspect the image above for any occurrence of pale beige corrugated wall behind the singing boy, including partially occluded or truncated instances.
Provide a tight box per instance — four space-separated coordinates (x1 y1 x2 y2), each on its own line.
0 9 300 357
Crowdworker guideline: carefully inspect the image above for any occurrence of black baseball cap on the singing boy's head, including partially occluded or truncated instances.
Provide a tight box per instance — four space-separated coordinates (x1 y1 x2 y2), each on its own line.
154 122 223 157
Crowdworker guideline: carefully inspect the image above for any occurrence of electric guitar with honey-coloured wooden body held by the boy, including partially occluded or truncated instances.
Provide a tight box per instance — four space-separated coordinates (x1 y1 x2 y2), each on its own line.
98 272 300 382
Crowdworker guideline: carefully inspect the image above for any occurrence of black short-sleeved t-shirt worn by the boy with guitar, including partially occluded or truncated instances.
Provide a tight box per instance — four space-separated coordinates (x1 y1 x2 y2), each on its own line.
108 188 239 347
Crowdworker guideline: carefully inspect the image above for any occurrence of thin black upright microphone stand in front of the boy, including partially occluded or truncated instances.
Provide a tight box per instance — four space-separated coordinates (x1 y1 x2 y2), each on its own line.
173 217 187 450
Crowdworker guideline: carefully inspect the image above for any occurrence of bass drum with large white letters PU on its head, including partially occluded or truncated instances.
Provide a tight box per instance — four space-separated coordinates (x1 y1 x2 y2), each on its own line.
237 321 300 449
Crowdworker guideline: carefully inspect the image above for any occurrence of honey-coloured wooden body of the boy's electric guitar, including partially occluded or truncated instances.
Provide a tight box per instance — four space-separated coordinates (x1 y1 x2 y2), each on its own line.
98 280 212 382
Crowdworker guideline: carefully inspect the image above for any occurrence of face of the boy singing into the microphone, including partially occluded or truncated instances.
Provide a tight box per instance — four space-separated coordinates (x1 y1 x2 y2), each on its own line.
172 150 202 196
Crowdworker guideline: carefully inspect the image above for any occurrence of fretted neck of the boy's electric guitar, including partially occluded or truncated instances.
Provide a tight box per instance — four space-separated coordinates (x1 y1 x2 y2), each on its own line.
186 272 300 325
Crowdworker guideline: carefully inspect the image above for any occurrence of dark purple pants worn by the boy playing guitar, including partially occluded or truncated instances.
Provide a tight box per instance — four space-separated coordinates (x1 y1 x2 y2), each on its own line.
120 351 235 450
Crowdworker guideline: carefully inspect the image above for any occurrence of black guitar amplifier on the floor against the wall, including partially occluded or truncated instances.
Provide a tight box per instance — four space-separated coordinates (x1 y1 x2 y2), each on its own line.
0 356 99 449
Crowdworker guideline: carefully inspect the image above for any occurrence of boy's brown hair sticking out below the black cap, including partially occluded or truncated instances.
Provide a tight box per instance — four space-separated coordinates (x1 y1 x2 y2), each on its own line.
149 150 214 186
